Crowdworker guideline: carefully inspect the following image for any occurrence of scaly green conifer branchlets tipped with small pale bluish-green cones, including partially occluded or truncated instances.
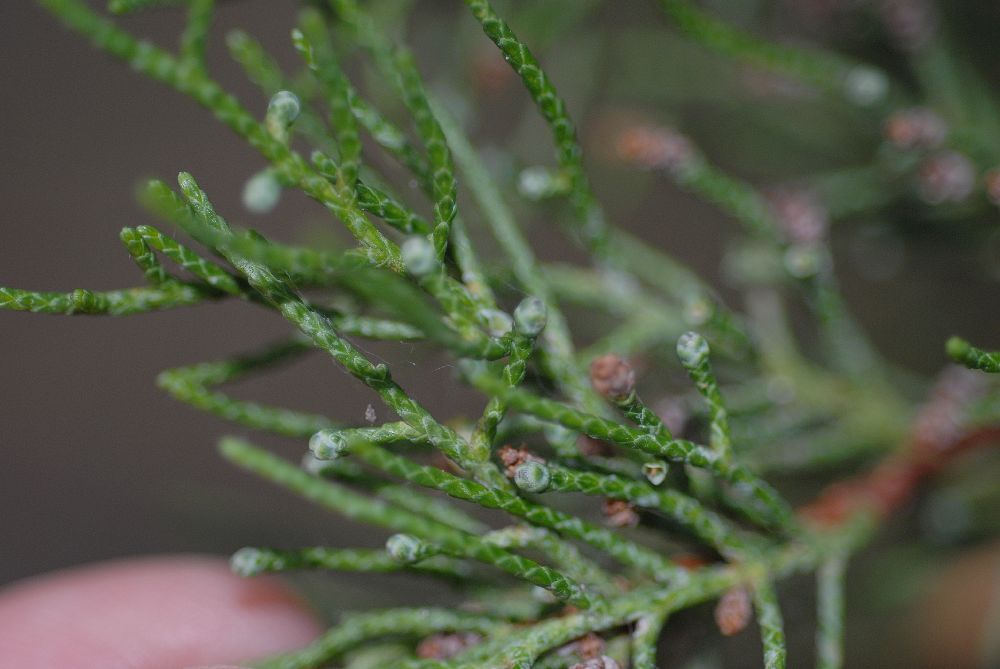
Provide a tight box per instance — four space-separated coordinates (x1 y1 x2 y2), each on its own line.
13 0 1000 669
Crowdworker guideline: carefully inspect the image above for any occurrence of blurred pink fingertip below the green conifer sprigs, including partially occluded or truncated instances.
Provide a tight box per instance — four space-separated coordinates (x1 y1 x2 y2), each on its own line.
0 556 320 669
